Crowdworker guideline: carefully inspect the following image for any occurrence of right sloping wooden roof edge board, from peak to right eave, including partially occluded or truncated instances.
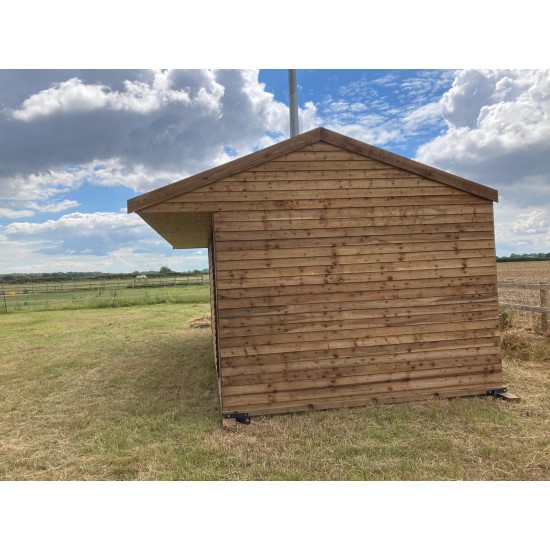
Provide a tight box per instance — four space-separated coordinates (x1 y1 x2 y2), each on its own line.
320 128 498 202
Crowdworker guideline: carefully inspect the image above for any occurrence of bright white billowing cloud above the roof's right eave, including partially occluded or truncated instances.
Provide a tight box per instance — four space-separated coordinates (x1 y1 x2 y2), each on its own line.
417 70 550 206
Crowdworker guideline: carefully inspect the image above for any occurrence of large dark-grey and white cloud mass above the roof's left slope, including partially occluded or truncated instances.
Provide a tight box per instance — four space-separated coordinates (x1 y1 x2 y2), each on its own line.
0 70 321 201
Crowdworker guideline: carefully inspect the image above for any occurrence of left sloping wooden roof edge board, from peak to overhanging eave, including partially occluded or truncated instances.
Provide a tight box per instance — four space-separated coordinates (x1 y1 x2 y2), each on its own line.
128 128 321 213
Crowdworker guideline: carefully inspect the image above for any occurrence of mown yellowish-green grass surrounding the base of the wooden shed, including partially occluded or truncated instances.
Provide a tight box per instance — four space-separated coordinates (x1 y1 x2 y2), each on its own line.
0 303 550 480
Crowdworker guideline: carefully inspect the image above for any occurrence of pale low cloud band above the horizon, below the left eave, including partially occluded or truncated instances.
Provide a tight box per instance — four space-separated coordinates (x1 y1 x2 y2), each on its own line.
0 212 208 273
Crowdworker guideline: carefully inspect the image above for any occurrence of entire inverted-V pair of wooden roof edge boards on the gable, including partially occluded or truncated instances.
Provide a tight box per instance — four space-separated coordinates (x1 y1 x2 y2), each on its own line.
128 128 498 213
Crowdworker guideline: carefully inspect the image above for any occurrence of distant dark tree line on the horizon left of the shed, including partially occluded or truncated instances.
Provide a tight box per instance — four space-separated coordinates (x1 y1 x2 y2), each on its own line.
0 266 208 283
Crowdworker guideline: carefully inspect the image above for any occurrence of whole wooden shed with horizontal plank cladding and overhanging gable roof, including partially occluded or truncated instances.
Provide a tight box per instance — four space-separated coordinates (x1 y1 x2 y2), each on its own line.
128 128 503 420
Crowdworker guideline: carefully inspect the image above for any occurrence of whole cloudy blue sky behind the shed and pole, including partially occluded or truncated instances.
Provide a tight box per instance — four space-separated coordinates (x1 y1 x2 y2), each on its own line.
0 69 550 273
